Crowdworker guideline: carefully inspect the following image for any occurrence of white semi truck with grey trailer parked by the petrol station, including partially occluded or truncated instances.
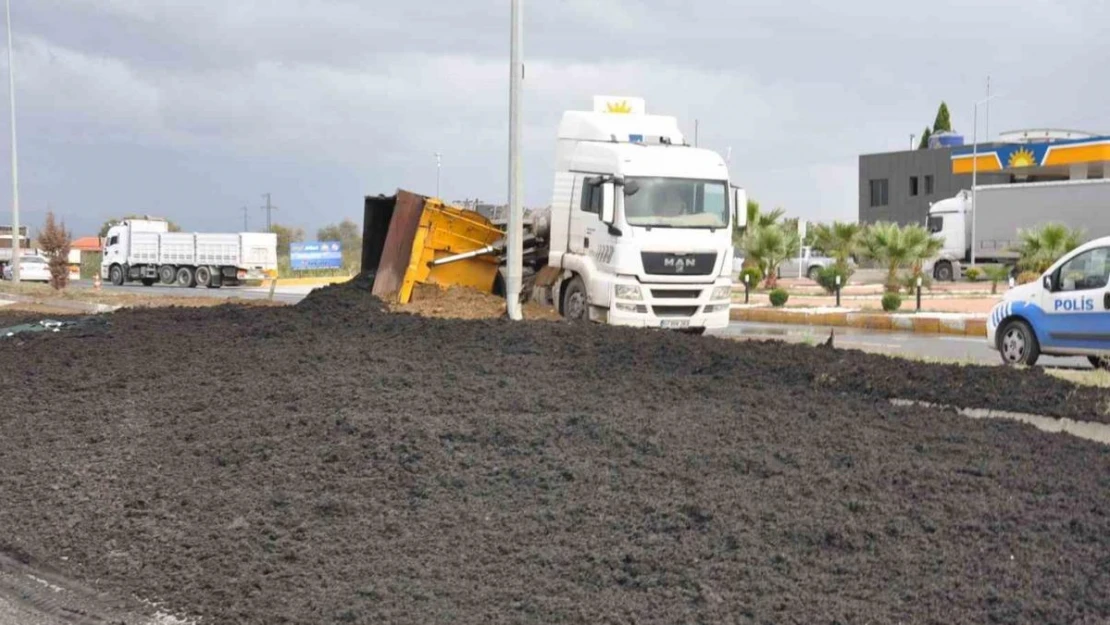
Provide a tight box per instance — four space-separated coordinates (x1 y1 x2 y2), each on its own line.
927 179 1110 281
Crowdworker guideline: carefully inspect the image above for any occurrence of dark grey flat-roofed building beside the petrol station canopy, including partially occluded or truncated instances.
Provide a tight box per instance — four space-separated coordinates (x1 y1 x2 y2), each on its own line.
859 143 1010 225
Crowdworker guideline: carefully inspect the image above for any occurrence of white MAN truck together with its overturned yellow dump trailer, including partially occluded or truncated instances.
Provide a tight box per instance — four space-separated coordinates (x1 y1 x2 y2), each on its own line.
362 97 747 333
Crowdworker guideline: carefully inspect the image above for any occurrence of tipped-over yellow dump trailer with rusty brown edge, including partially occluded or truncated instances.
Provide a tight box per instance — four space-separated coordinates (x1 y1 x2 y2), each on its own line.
362 190 504 304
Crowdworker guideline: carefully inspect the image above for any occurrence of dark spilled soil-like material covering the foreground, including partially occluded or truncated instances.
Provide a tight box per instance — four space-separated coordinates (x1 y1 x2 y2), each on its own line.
0 279 1110 624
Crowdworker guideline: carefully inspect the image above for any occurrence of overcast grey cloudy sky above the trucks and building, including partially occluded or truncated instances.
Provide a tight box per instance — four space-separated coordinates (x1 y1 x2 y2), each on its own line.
0 0 1110 236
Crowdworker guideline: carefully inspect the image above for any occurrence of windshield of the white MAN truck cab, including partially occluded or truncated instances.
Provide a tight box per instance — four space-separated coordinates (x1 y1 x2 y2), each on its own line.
625 178 728 228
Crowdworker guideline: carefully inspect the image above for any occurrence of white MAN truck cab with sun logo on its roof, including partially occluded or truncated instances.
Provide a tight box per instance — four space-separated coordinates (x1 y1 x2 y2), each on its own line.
548 97 747 332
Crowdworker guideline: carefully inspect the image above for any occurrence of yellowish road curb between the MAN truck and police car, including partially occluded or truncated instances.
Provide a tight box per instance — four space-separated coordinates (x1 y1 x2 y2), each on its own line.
729 308 987 337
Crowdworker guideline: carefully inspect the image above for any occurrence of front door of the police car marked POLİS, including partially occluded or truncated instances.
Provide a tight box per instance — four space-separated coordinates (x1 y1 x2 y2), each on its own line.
1037 246 1110 351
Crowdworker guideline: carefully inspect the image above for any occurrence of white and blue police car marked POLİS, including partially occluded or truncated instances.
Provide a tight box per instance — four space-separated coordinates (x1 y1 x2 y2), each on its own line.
987 236 1110 369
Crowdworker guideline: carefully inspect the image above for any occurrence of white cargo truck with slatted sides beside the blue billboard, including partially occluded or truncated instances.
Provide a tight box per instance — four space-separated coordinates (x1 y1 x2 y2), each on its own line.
100 219 278 289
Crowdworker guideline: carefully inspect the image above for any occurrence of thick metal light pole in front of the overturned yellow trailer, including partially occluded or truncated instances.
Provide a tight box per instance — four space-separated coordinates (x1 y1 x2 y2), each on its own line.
505 0 524 321
